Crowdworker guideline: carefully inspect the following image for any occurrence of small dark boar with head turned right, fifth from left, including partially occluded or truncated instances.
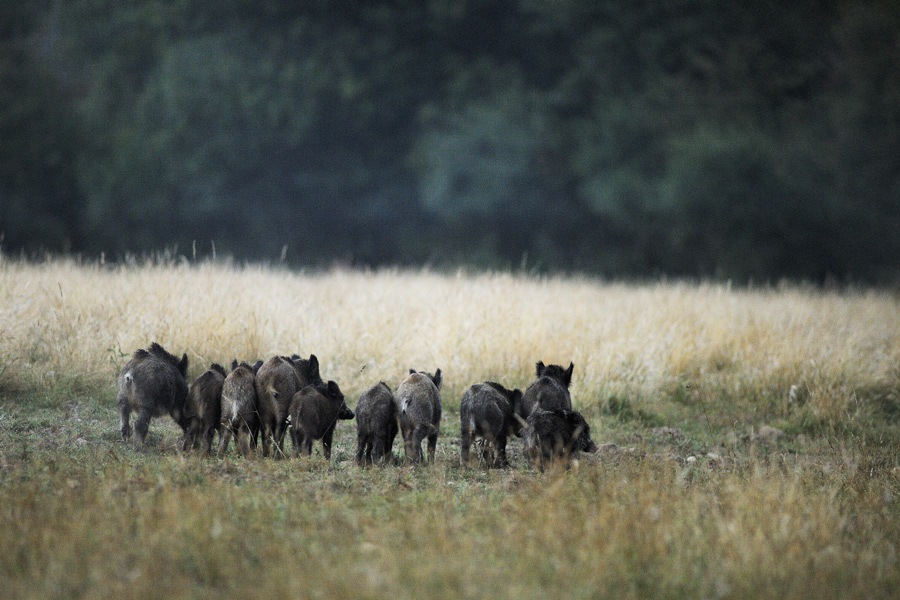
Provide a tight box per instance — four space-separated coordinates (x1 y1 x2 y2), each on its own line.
291 381 353 460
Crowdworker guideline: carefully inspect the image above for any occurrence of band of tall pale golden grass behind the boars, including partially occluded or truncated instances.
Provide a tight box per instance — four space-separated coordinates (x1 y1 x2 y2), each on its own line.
0 261 900 419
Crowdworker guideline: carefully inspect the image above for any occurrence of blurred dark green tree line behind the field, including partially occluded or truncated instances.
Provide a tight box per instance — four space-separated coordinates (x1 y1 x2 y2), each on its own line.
0 0 900 284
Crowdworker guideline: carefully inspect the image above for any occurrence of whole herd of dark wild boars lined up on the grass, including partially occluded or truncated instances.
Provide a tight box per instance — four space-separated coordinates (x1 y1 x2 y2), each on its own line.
117 342 597 470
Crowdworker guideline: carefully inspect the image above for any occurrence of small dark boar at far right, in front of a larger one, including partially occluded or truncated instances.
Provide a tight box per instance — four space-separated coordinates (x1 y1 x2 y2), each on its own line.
524 408 597 471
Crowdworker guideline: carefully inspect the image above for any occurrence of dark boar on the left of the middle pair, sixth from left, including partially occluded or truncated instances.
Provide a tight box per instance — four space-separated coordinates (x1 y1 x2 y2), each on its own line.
356 381 397 465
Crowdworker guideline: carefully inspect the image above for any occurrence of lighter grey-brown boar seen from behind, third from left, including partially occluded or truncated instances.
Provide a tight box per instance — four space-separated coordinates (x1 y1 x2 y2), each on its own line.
219 361 259 458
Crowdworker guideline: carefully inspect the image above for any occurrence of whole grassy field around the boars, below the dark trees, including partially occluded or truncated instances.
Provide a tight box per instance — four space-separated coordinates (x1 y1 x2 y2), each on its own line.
0 259 900 599
